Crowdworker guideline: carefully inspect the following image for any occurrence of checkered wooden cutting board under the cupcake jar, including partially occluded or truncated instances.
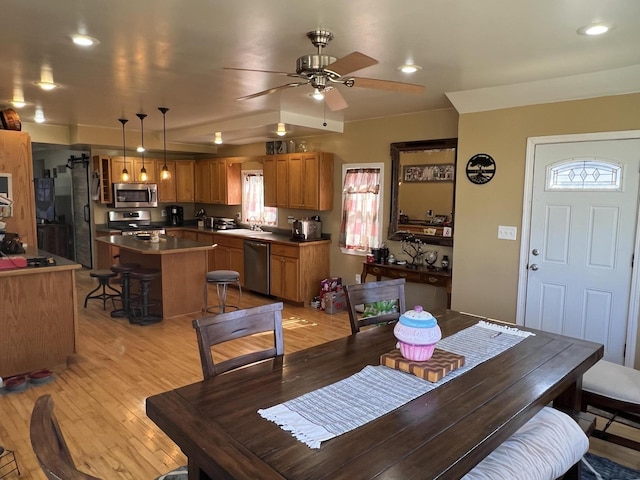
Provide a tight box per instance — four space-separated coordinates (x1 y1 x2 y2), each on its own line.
380 348 464 383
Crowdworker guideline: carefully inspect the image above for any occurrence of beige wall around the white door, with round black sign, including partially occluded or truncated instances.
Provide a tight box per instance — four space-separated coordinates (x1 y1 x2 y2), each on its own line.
452 94 640 322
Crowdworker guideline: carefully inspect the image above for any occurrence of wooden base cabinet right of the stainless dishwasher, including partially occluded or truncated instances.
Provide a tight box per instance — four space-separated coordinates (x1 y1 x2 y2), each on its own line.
270 241 331 305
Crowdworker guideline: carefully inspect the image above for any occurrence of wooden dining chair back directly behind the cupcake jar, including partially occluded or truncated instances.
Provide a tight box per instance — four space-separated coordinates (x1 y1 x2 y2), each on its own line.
344 278 406 333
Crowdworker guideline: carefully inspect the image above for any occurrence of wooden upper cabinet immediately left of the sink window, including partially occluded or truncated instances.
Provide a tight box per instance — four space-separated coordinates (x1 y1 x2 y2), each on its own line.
195 157 243 205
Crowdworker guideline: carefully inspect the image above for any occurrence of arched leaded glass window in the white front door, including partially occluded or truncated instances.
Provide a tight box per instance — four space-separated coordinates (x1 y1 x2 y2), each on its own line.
547 157 622 191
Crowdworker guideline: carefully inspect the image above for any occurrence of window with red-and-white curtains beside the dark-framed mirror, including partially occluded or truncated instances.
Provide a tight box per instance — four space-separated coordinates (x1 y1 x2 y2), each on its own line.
340 163 384 255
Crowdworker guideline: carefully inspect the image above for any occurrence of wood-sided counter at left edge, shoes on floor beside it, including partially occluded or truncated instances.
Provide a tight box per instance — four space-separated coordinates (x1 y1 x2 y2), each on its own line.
0 249 82 378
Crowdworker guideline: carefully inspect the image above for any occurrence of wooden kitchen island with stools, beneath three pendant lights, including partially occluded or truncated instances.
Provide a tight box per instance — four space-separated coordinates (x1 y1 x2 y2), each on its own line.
96 235 214 319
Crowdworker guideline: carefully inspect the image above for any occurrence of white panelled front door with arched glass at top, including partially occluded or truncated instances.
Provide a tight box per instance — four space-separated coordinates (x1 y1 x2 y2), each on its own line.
524 139 640 364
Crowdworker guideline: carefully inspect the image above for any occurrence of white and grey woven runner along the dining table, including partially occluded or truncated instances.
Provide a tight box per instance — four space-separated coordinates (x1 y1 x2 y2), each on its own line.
258 321 534 448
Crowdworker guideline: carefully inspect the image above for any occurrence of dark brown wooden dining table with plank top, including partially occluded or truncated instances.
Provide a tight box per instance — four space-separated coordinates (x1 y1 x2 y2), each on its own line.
146 310 604 480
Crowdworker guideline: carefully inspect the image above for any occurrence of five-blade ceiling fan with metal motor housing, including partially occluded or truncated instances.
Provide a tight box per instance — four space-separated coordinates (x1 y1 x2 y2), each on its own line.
225 30 424 111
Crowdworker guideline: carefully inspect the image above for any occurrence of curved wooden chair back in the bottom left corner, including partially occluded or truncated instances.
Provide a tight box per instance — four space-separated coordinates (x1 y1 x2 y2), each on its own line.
29 395 100 480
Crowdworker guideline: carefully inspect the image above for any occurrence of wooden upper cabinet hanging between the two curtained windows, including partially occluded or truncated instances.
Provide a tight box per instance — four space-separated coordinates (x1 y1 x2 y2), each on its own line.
263 152 333 210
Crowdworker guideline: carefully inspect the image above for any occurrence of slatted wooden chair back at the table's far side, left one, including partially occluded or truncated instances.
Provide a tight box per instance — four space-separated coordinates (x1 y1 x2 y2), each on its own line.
193 302 284 380
